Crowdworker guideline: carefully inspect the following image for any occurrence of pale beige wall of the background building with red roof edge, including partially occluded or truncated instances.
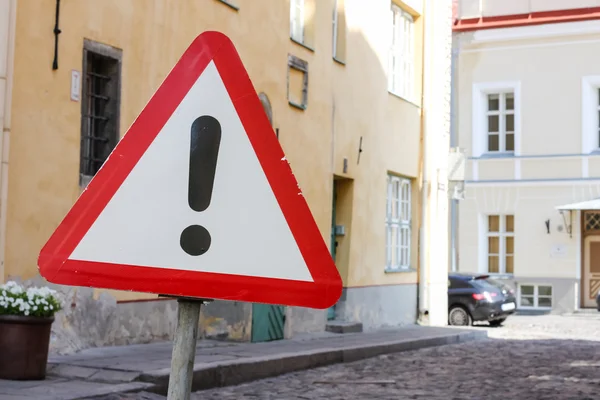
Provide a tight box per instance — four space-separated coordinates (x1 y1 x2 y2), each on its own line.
455 18 600 311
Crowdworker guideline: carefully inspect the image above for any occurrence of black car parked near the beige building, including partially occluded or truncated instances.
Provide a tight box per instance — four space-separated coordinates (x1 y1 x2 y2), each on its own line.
448 273 517 326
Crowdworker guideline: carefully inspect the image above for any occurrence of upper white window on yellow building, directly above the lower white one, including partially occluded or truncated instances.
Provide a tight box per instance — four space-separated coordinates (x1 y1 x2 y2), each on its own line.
388 2 415 102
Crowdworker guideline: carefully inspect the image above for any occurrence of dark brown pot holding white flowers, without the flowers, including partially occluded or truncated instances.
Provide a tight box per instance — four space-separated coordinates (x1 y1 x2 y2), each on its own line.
0 315 54 380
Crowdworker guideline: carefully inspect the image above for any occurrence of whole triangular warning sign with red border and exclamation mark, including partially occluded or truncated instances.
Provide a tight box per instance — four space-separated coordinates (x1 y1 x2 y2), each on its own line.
38 32 342 308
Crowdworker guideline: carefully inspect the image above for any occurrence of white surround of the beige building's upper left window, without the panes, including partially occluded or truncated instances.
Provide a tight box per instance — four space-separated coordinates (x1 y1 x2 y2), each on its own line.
471 81 521 157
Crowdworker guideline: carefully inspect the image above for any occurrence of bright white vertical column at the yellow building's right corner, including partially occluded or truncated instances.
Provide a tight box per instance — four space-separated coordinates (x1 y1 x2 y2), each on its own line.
419 0 452 326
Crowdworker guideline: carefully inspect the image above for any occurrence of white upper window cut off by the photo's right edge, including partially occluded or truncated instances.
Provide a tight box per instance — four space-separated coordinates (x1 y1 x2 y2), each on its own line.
581 75 600 154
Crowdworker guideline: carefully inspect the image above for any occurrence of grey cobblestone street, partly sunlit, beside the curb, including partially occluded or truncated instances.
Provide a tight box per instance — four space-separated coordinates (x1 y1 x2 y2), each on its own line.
193 314 600 400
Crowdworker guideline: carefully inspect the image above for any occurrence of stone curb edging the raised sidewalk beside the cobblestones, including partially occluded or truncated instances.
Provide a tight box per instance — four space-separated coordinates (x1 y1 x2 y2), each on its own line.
138 330 488 393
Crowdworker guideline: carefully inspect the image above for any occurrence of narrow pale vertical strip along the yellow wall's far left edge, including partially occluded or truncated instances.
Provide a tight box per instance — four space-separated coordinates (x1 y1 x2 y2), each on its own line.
0 0 17 282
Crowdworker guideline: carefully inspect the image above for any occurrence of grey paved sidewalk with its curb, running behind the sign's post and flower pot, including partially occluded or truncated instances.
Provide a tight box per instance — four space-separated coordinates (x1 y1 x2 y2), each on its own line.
0 325 487 400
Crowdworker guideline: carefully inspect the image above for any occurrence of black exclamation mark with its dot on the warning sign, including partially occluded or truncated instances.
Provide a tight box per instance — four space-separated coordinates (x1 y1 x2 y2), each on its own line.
179 115 221 256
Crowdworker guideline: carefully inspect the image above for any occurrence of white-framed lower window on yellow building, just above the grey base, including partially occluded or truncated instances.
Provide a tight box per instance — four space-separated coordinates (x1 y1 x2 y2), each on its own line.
385 174 412 271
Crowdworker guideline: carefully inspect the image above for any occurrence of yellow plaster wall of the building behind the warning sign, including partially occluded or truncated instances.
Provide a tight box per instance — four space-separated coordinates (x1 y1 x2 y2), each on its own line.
5 0 422 300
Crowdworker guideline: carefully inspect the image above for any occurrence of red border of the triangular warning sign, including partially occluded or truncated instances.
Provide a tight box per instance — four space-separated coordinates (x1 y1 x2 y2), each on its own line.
38 31 342 309
